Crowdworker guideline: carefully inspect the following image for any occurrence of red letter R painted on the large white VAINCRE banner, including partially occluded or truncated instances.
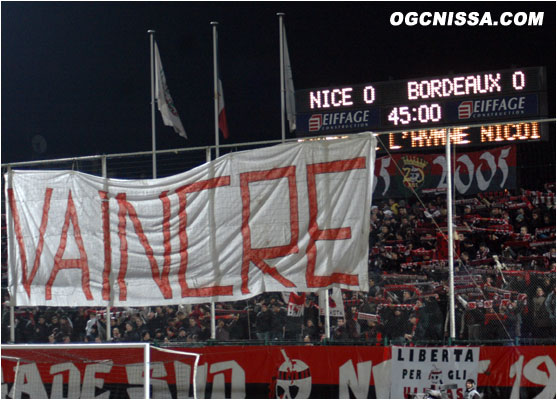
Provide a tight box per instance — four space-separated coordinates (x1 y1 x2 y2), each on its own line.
240 166 299 294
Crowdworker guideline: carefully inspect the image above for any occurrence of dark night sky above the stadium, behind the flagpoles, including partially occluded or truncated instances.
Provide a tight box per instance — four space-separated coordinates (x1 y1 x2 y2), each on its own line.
1 2 556 163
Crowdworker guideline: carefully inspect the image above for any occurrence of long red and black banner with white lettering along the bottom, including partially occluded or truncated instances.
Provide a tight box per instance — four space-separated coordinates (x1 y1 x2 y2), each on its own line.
2 345 556 399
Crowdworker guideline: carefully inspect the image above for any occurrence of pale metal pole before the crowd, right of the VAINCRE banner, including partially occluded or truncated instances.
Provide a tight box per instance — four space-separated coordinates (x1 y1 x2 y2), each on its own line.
445 128 456 343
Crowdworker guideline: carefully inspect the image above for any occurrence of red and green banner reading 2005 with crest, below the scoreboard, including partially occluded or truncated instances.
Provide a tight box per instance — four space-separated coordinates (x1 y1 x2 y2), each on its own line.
373 146 516 199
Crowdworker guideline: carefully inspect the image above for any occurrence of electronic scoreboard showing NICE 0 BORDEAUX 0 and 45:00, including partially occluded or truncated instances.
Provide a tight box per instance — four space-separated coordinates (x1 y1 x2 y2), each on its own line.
295 67 547 148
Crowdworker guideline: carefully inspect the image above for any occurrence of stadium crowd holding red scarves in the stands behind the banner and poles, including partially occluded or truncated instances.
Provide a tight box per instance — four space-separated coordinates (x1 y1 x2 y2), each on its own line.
2 189 556 344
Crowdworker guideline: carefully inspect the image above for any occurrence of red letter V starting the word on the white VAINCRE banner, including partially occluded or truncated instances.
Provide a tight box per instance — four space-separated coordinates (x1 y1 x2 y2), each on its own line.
8 188 53 298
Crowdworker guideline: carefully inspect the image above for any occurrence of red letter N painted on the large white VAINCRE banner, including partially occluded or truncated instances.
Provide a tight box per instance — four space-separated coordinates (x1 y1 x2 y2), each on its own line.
116 192 172 301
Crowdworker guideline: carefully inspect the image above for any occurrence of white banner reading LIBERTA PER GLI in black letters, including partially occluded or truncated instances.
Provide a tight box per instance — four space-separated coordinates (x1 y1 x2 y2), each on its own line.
391 346 481 399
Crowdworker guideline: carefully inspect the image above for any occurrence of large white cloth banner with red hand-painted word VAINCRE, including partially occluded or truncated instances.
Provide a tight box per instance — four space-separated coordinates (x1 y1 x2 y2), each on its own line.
5 133 376 306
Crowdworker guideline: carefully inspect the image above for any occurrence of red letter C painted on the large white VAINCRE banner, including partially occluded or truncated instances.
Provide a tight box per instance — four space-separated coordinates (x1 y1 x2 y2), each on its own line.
176 176 234 297
